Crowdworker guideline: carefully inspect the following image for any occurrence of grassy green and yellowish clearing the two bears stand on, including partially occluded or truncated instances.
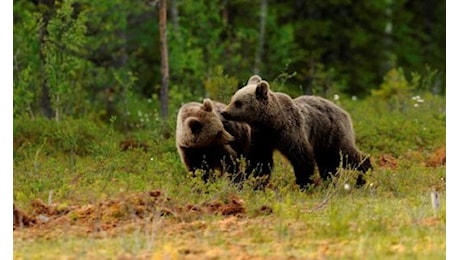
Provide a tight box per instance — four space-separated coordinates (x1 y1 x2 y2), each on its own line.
14 95 446 259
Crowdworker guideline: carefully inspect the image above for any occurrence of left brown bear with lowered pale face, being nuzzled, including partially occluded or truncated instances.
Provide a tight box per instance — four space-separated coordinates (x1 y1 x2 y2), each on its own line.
176 99 251 182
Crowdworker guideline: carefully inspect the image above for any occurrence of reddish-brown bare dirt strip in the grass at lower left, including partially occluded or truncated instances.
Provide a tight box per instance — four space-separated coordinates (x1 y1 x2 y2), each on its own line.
13 190 266 238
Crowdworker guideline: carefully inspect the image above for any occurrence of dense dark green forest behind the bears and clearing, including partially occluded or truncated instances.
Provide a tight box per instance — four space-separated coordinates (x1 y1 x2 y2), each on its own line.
13 0 446 126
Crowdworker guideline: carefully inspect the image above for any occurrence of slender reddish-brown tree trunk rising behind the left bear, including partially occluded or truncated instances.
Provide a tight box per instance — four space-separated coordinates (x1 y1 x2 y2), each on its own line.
159 0 169 119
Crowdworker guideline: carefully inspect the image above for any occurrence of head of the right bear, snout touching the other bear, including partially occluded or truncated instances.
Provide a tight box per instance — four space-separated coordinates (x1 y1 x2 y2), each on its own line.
221 75 270 125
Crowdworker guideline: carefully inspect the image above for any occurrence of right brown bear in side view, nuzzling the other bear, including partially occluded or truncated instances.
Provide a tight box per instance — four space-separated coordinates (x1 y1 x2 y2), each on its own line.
222 75 372 188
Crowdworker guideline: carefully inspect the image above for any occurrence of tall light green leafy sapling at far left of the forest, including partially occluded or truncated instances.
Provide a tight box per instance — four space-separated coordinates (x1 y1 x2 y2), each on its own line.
43 0 89 121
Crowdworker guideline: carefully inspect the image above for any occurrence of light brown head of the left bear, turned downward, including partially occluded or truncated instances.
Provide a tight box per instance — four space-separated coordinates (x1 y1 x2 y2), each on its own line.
176 98 234 148
